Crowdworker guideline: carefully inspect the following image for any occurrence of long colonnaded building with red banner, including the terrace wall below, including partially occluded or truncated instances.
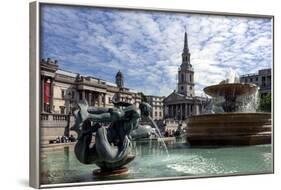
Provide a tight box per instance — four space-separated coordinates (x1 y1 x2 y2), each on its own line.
40 58 141 142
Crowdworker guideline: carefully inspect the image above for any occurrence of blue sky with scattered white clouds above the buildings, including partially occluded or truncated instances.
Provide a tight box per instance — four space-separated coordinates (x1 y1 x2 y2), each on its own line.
41 5 272 96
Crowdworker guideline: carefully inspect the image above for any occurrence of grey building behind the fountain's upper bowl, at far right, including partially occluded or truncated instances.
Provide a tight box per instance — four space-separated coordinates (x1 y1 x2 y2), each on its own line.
240 69 271 96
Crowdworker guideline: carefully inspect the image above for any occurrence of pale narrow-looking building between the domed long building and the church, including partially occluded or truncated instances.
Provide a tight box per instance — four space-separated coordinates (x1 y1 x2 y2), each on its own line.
145 95 165 121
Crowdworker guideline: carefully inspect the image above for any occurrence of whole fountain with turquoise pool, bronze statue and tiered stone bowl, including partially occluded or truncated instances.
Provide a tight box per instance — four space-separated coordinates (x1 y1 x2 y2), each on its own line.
40 71 273 184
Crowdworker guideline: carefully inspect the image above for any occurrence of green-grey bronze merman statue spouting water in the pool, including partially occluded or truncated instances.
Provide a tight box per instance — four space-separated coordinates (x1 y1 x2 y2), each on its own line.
72 101 151 173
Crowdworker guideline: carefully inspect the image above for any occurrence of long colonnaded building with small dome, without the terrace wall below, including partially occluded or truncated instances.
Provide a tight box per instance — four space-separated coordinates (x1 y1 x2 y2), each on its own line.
40 58 141 114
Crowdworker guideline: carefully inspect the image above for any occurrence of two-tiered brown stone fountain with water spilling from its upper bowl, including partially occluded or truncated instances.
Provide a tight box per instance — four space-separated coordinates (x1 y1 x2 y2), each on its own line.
187 72 271 146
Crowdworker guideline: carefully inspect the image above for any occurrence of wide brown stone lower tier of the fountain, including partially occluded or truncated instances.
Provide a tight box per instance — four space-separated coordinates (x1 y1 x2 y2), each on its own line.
187 112 272 146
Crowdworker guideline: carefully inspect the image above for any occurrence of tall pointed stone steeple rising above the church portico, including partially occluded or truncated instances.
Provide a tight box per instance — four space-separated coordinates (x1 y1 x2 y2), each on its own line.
178 32 195 97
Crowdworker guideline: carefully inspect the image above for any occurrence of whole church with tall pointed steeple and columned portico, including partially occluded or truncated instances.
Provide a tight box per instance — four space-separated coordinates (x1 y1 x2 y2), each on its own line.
163 32 208 121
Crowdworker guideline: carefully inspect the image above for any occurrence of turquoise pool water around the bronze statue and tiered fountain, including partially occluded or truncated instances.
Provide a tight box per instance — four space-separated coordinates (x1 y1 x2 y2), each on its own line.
41 140 273 184
